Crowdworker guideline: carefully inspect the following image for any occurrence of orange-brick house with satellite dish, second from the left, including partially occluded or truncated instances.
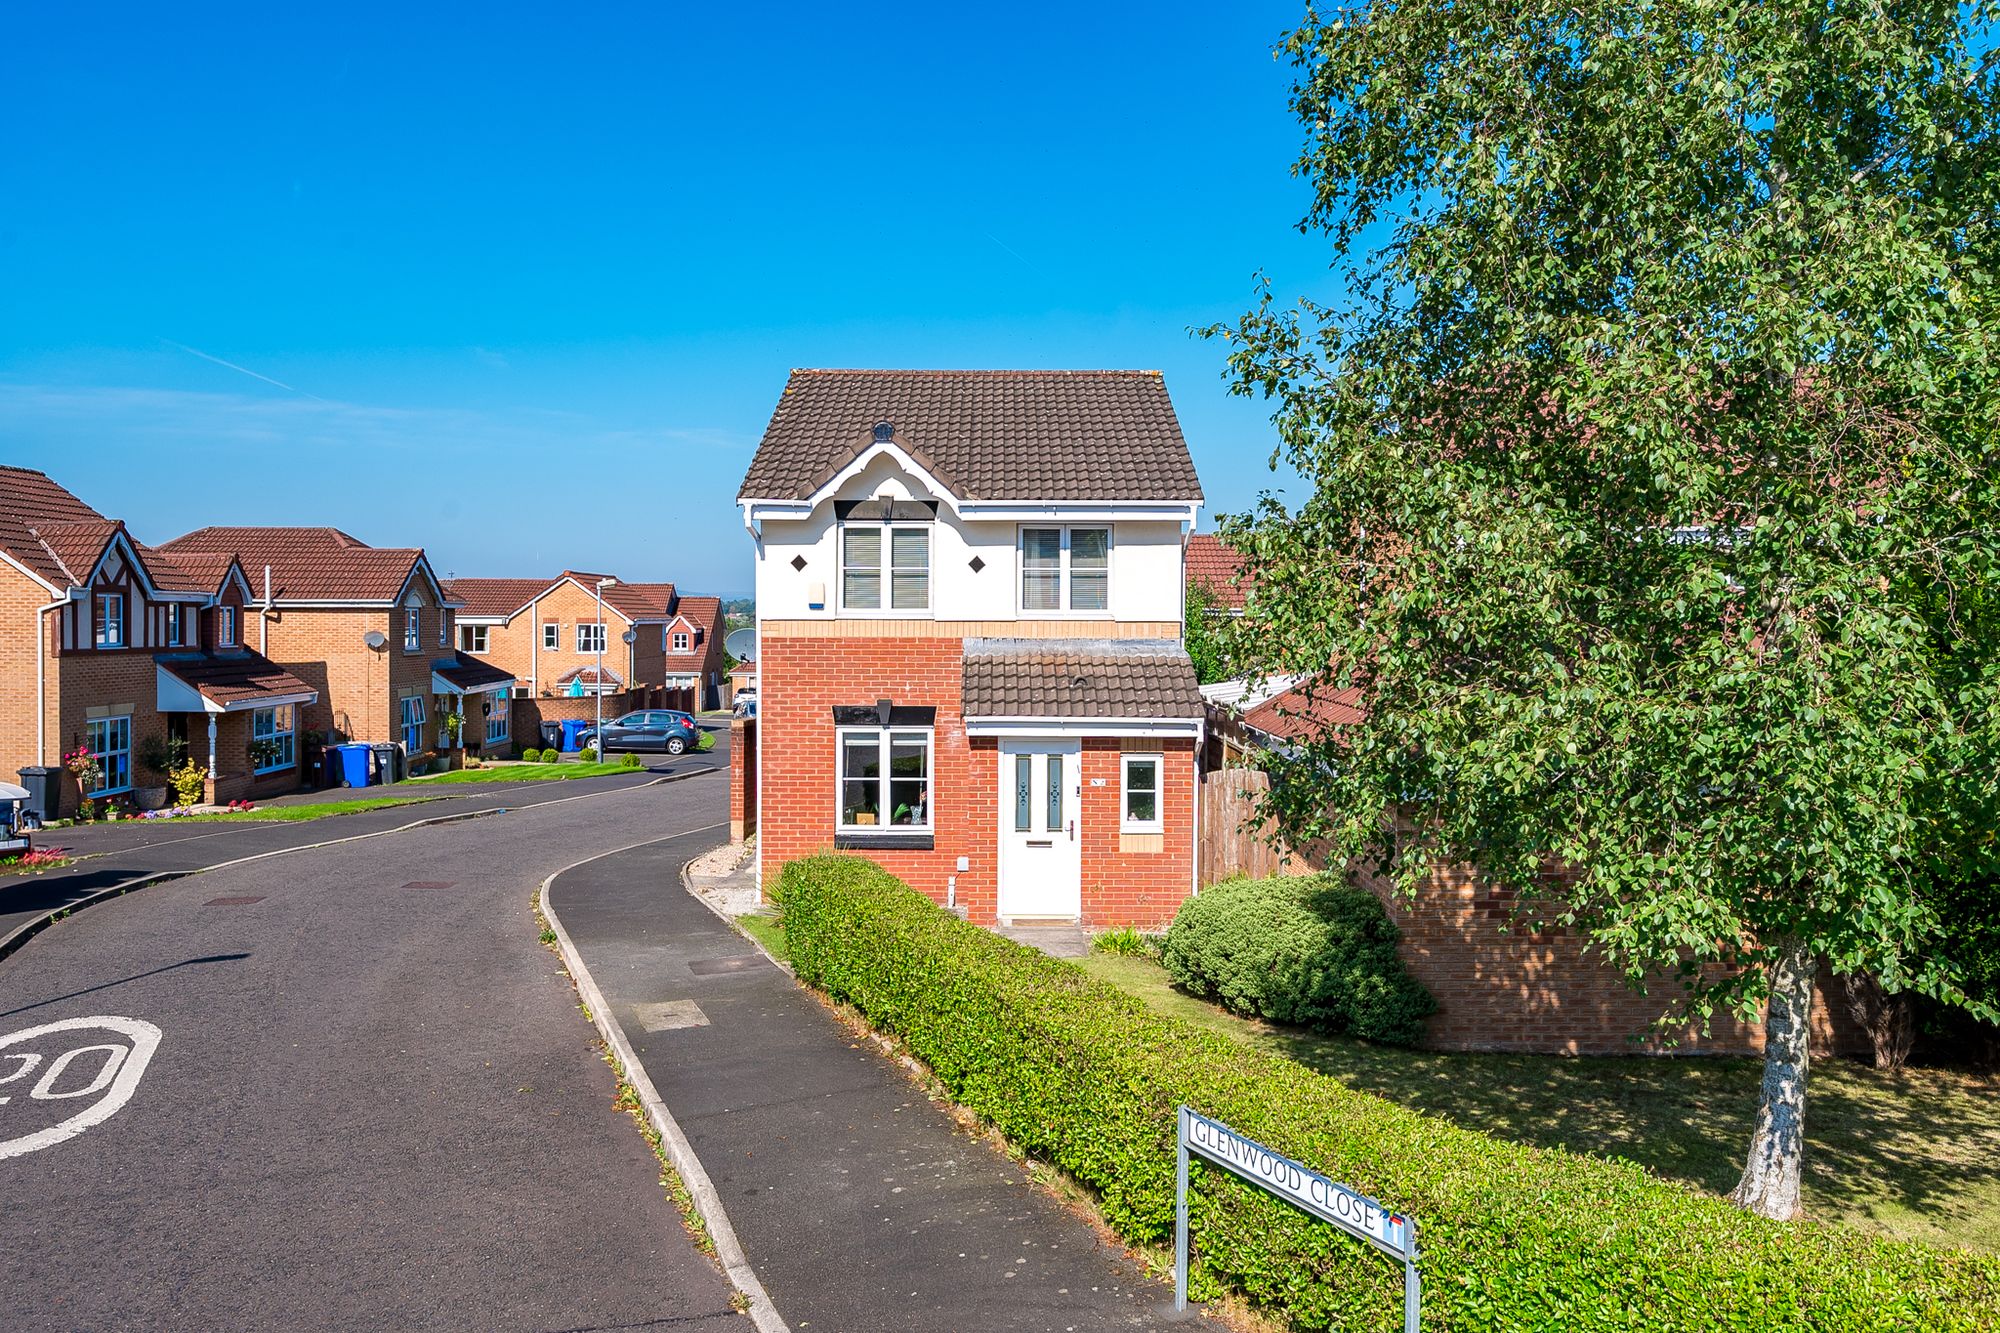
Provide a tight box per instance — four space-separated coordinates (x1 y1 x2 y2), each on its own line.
162 526 514 763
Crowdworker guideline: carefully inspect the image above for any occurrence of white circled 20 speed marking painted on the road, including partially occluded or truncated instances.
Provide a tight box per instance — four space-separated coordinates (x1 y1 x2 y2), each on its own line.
0 1015 160 1159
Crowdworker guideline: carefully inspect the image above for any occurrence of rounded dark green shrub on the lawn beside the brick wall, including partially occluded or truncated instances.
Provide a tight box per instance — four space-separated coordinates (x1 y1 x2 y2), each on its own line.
1160 875 1438 1045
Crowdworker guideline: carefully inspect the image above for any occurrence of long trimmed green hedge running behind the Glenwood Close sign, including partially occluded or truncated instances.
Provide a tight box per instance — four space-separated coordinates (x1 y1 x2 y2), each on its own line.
778 855 2000 1333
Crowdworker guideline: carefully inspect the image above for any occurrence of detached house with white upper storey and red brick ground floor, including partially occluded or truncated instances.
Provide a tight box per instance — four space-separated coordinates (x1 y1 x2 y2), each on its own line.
738 370 1202 927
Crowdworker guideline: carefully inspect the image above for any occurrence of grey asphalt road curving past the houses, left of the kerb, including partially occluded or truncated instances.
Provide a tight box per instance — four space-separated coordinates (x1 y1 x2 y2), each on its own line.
0 775 748 1329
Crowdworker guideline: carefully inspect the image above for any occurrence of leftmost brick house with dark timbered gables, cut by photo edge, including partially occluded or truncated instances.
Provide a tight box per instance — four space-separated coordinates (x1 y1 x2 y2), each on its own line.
0 466 318 817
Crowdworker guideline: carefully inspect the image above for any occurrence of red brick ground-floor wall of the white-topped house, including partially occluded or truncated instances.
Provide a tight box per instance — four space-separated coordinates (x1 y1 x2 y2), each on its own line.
756 636 1196 929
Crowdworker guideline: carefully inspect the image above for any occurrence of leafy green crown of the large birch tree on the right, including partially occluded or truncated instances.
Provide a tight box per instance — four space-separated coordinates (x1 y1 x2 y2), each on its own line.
1212 0 2000 1015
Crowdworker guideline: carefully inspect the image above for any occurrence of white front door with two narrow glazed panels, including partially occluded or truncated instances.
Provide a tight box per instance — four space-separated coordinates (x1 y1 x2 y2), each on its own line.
1000 741 1084 921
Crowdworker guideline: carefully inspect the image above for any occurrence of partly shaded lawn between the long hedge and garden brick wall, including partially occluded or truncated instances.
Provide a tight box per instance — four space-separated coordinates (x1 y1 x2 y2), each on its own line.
1078 953 2000 1253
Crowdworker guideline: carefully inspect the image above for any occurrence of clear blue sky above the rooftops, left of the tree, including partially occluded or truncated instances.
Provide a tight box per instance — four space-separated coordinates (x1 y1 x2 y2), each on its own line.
0 0 1332 594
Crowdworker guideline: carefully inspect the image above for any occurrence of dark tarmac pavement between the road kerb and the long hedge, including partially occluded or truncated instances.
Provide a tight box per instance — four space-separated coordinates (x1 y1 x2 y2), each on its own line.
548 835 1176 1333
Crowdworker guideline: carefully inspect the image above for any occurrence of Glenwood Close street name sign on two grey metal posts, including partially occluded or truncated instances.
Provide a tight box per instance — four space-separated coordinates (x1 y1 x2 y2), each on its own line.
1174 1107 1424 1333
